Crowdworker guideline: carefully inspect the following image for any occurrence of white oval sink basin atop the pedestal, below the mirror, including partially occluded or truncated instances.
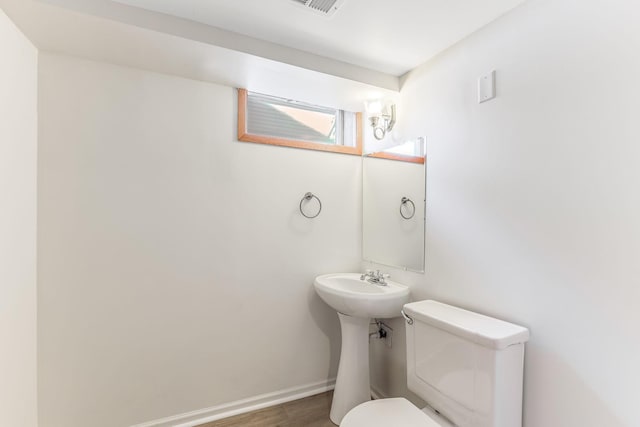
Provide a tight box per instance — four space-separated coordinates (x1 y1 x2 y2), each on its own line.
313 273 409 318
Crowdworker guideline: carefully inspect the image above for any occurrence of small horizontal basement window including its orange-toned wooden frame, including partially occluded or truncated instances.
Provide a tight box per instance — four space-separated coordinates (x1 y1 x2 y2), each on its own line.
238 89 362 155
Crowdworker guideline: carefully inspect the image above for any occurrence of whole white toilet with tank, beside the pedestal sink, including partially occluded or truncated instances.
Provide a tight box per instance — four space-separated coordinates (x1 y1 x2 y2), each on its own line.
340 300 529 427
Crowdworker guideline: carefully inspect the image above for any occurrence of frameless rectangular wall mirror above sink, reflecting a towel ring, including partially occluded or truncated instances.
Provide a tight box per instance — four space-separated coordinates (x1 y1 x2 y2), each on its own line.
362 138 426 272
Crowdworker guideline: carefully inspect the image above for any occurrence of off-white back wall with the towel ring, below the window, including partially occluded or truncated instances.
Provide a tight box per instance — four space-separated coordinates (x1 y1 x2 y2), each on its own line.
38 53 361 427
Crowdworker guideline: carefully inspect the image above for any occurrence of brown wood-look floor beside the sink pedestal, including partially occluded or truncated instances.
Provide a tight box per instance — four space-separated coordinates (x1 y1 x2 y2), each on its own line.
198 391 335 427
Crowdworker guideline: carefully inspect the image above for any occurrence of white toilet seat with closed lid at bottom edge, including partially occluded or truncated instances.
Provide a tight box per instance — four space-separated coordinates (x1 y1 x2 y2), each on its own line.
340 397 442 427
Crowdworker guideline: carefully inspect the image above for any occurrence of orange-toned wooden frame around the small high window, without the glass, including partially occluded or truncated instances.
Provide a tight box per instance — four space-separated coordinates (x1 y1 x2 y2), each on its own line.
238 89 362 156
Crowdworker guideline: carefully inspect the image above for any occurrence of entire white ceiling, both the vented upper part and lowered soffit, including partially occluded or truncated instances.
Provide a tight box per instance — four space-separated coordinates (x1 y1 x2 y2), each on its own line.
0 0 524 111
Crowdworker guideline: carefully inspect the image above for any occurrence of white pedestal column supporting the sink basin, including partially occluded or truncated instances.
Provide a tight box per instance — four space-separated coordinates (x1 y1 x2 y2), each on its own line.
329 313 371 425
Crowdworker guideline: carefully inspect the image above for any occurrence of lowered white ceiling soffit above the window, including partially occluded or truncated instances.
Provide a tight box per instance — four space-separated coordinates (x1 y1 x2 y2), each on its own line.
0 0 399 111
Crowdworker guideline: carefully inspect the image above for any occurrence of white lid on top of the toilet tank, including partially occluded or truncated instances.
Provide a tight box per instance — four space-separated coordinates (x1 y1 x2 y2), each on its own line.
403 300 529 350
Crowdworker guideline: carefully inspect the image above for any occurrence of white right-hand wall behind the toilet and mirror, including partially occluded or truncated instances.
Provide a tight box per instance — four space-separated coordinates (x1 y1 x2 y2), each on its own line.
373 0 640 427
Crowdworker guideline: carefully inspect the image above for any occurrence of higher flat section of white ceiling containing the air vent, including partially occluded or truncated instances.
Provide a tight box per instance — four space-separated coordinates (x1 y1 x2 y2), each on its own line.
115 0 524 76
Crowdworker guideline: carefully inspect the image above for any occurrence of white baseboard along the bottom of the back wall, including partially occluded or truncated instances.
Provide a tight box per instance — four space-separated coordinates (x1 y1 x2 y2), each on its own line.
131 378 336 427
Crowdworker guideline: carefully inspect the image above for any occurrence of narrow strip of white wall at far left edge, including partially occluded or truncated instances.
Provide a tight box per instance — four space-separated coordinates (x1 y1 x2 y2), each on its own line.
0 6 38 427
